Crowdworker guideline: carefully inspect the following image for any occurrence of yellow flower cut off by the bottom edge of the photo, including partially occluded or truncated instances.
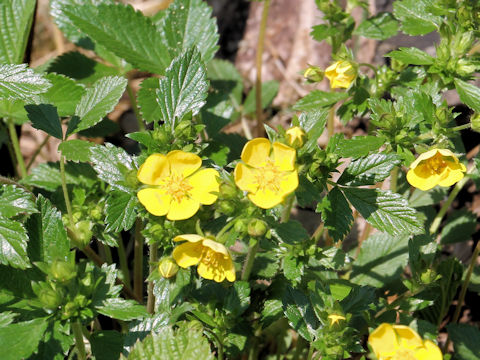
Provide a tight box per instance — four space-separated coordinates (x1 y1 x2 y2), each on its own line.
368 323 442 360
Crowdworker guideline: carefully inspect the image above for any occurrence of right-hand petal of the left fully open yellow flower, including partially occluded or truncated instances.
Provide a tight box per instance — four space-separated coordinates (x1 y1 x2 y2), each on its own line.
187 169 220 205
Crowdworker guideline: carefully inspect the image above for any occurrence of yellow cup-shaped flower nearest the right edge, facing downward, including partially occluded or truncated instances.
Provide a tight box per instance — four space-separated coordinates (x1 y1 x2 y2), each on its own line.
407 149 467 191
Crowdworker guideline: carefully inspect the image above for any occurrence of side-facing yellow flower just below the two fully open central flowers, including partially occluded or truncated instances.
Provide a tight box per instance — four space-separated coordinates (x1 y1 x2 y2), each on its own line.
173 234 235 282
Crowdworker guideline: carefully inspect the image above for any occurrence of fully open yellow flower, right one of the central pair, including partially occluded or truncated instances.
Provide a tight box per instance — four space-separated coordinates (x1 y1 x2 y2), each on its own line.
234 138 298 209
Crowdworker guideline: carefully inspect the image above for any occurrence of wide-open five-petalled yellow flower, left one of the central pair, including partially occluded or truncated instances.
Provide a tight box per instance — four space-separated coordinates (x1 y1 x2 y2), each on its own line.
137 150 219 220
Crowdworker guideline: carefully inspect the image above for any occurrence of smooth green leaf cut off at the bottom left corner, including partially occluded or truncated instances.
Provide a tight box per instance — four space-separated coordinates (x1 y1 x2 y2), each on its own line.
0 318 48 360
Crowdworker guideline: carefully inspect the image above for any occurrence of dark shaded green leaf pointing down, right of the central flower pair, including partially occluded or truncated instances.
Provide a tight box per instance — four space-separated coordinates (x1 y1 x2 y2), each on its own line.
317 187 353 241
